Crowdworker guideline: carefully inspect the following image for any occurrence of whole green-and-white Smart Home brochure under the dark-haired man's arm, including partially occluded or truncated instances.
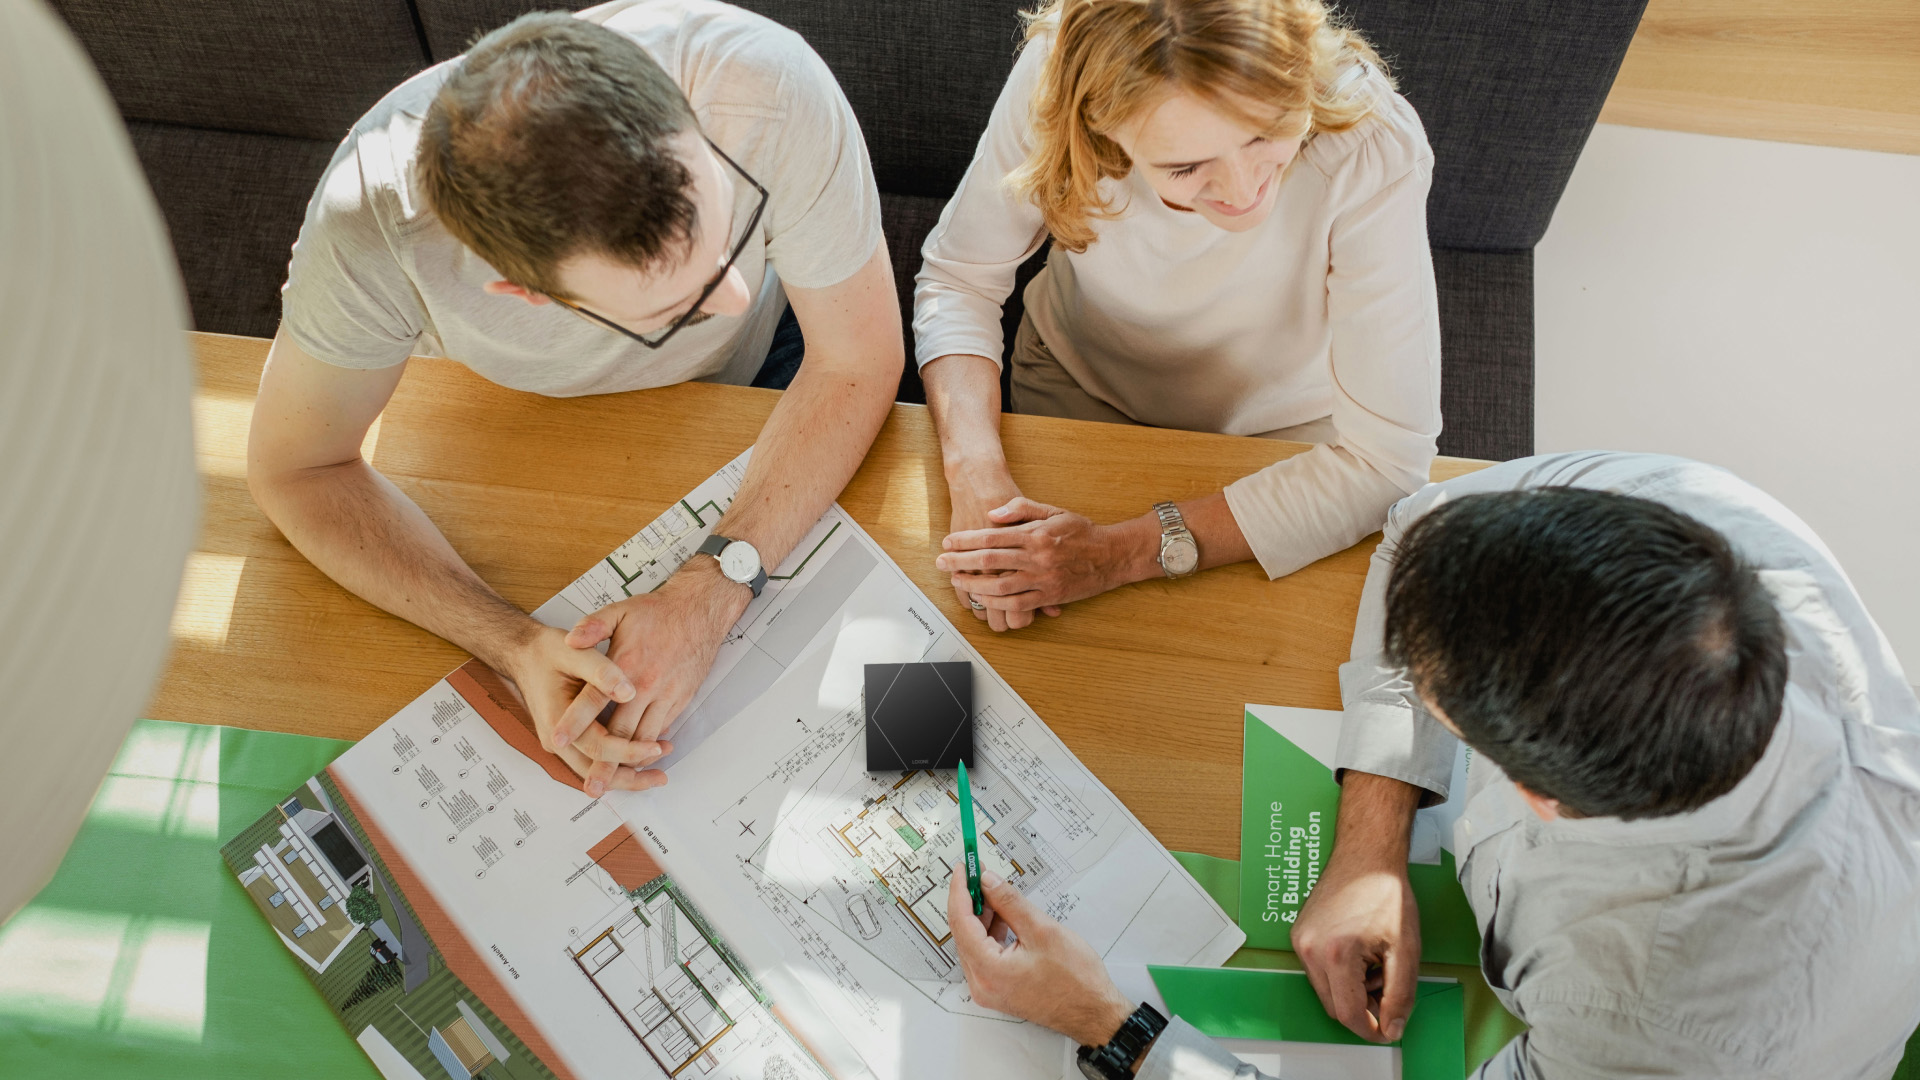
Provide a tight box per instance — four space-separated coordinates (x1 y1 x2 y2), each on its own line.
1238 705 1480 965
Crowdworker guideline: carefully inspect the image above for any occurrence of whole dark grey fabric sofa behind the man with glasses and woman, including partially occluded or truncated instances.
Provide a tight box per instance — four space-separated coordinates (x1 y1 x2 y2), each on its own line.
52 0 1645 457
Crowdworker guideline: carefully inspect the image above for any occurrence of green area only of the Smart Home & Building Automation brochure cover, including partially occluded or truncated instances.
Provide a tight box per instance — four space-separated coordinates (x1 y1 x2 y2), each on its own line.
1238 713 1480 965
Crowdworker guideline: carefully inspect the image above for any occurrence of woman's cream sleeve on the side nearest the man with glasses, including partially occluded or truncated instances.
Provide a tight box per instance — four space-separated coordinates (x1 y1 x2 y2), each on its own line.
914 38 1052 365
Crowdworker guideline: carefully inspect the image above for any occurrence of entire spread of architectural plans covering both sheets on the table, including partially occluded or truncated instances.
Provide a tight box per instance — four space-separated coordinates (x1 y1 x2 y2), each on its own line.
223 455 1244 1080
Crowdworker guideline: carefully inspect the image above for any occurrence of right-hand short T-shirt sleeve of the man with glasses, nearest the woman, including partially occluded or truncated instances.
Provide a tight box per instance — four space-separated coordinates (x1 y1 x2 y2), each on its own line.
760 35 881 288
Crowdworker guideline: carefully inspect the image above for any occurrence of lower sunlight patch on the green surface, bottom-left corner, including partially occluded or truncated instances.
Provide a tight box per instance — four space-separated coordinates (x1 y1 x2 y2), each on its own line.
0 905 213 1043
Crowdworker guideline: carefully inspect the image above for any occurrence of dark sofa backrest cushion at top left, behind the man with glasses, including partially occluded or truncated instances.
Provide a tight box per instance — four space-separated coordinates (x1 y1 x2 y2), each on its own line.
52 0 426 142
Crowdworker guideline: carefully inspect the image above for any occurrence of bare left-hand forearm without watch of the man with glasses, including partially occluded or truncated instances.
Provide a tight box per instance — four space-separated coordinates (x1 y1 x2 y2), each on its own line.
253 457 538 671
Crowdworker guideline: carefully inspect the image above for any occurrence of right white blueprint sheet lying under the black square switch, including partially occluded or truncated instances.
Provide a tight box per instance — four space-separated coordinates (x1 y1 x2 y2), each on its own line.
616 521 1244 1076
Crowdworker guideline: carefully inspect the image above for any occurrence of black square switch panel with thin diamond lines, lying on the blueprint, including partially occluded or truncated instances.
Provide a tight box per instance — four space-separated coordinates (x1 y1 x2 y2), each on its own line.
866 661 973 773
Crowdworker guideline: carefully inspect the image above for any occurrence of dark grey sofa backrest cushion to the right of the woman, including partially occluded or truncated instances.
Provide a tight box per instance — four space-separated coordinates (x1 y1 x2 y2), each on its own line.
1340 0 1645 252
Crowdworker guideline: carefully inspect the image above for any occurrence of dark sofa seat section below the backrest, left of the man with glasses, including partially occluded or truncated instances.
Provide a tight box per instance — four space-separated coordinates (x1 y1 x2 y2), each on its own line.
127 121 334 338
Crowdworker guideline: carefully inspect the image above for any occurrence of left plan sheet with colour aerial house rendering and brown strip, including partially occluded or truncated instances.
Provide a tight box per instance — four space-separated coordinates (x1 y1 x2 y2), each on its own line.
225 663 828 1080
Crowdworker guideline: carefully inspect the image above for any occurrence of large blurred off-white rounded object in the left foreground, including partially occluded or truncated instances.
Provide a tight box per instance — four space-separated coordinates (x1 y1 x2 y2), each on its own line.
0 0 200 919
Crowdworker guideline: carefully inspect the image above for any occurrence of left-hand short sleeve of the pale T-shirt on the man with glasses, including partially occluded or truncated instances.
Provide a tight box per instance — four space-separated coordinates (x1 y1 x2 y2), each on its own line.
280 131 428 369
